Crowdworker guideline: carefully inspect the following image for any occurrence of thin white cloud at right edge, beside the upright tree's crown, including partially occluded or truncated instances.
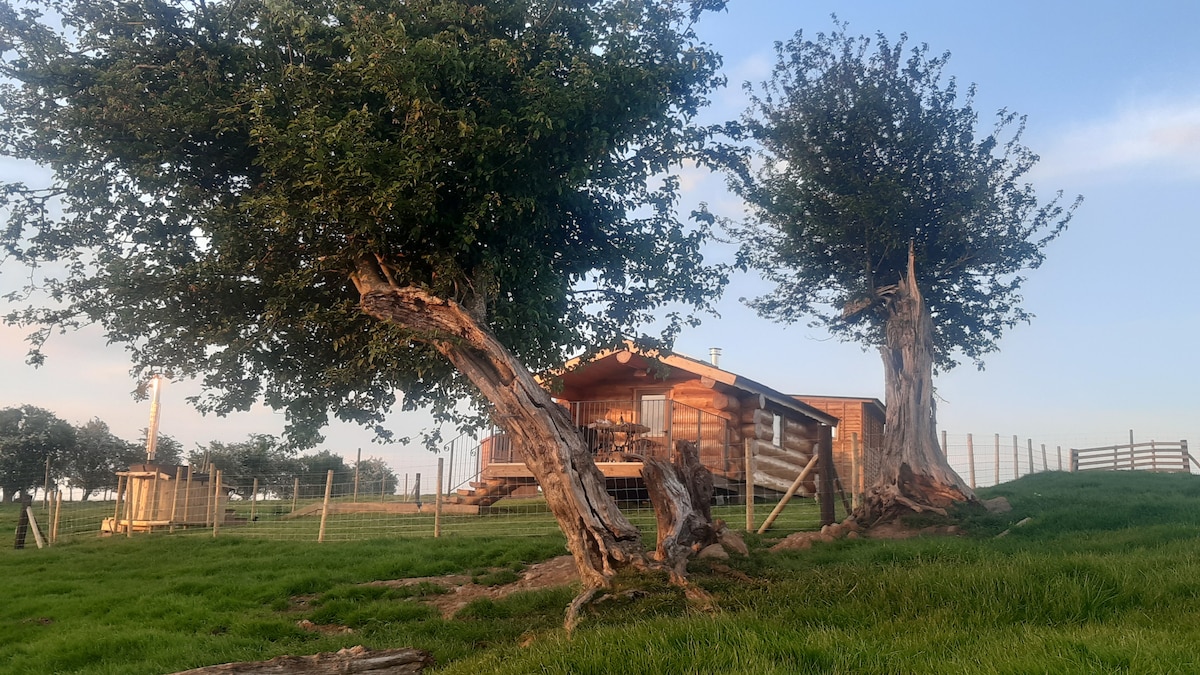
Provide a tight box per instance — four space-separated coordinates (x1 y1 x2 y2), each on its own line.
1037 98 1200 179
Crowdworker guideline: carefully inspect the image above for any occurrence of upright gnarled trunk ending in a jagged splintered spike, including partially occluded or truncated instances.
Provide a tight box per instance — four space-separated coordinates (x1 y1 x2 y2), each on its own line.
856 243 974 524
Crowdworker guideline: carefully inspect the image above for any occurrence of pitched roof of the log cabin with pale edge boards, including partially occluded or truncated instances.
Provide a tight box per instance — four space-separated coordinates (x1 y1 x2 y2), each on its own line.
558 342 838 426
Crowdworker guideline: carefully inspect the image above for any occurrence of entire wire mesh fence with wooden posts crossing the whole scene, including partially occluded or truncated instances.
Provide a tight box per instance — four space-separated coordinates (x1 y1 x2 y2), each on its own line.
14 434 1196 543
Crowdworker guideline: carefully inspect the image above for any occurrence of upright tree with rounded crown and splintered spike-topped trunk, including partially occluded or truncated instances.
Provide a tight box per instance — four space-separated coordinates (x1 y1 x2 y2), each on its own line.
734 25 1078 521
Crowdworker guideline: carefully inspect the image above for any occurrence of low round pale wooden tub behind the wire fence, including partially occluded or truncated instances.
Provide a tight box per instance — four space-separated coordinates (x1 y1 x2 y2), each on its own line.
102 464 229 532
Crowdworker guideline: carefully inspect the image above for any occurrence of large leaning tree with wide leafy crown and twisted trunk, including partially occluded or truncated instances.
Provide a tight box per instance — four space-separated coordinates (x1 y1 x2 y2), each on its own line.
0 0 724 586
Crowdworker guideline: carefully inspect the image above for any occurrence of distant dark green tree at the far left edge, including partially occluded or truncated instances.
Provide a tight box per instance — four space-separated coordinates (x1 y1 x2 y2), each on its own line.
0 406 76 502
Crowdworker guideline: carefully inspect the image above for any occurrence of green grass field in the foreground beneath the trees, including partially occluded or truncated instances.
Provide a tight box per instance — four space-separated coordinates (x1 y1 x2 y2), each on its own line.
0 473 1200 675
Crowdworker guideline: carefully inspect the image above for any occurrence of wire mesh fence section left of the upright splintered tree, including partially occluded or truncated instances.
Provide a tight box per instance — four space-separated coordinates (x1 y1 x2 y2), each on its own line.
21 458 850 544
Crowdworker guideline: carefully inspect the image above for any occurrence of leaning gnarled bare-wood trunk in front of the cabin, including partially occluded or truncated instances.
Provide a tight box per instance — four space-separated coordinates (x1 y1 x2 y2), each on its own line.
354 264 649 589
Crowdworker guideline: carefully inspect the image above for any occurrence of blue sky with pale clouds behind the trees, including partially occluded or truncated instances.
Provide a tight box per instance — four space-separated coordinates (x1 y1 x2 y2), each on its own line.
0 0 1200 466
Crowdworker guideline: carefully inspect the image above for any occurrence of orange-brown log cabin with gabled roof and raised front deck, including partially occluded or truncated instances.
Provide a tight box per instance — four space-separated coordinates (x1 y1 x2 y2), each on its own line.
460 345 838 506
